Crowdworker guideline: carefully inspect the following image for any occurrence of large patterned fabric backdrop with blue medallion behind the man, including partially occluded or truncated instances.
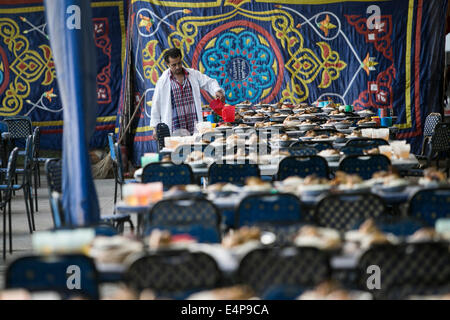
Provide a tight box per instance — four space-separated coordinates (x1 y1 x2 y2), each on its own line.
123 0 447 164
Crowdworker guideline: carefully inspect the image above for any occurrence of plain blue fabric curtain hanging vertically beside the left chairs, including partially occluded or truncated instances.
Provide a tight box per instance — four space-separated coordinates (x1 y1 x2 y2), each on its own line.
45 0 100 226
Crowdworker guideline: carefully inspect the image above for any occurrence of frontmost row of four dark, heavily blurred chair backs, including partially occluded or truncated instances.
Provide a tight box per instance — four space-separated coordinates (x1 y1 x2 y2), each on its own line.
5 242 450 299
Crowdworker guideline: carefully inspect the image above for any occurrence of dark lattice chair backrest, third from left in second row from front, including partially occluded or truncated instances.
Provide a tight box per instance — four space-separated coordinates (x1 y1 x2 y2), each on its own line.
314 192 386 232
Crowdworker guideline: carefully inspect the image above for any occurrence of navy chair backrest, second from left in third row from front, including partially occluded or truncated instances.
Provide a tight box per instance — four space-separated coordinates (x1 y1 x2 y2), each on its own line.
208 162 261 185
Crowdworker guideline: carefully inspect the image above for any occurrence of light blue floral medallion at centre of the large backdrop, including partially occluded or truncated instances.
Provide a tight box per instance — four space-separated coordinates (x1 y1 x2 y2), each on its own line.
201 32 276 104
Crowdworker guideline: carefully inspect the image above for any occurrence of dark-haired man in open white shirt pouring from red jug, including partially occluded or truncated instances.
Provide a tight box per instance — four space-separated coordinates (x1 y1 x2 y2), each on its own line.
150 48 225 135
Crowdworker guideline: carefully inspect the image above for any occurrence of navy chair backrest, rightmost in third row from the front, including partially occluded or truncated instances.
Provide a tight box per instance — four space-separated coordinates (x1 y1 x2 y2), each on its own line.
338 154 391 180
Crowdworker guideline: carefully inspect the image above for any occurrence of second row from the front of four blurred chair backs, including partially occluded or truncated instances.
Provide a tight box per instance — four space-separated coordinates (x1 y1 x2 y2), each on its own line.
144 188 450 243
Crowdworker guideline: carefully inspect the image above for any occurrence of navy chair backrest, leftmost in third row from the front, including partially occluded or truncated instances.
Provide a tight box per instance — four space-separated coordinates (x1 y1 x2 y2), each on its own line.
141 162 194 190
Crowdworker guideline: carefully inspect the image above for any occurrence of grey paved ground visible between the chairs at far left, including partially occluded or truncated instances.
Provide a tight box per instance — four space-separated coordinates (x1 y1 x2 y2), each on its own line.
0 170 130 288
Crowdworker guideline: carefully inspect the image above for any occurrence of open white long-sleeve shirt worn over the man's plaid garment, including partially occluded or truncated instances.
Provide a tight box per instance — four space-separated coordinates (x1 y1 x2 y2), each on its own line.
150 68 223 132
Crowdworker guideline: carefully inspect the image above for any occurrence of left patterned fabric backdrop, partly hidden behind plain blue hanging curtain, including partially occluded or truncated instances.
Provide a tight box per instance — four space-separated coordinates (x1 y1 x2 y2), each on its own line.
0 0 127 150
